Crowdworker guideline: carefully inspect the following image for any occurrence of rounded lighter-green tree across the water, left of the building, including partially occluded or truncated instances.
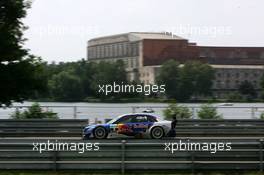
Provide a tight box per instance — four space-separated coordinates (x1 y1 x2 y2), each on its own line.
49 71 84 101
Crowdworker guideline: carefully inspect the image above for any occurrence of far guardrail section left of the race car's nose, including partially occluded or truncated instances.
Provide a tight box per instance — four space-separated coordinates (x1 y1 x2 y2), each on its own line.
0 119 89 137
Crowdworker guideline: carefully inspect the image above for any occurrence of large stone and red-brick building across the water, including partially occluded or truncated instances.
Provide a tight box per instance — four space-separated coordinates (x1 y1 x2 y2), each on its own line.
87 32 264 96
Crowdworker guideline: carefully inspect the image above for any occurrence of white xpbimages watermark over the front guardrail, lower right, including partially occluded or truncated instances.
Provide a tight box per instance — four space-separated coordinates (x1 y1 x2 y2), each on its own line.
164 140 232 154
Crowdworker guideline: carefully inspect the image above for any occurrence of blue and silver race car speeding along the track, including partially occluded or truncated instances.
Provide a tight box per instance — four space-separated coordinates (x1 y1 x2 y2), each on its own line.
83 113 171 139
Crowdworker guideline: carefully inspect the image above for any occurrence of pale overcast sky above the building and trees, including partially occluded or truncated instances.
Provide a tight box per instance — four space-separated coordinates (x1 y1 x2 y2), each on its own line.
23 0 264 62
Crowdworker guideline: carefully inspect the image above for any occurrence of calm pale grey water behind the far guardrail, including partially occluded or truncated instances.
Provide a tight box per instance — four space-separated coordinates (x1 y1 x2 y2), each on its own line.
0 102 264 121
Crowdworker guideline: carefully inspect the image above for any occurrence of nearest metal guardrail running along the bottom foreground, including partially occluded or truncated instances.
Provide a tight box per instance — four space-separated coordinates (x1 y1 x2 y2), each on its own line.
0 138 264 174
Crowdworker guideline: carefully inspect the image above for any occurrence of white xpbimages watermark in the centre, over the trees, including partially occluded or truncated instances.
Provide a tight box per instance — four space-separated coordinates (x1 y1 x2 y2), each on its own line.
98 82 166 96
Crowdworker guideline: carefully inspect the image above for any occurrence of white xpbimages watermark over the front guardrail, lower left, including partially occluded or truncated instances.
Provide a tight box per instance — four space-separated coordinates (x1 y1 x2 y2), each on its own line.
33 140 100 154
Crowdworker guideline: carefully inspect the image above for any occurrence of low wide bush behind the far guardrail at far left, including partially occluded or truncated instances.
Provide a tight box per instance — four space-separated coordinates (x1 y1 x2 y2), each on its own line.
11 103 58 119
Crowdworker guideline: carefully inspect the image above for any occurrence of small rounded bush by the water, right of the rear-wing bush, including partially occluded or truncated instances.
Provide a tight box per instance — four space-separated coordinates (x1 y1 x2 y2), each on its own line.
198 104 223 119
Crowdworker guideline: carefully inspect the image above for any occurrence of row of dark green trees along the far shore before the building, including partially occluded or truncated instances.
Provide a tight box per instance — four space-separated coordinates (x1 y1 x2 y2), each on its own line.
13 59 217 102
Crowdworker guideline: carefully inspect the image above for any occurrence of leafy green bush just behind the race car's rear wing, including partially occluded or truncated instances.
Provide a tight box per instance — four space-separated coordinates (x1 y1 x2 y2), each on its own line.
163 103 192 119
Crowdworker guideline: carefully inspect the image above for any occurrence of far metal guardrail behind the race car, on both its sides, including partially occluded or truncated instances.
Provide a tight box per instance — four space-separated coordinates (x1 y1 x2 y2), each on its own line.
0 119 264 137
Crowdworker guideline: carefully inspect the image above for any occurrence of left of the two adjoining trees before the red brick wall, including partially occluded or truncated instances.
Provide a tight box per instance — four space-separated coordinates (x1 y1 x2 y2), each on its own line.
157 60 179 99
